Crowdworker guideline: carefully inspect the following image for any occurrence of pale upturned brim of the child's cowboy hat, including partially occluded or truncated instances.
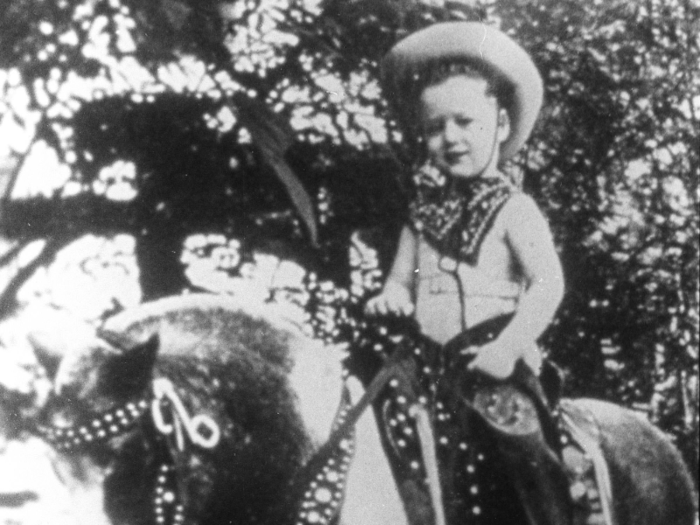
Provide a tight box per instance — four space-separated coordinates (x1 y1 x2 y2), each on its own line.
381 22 543 161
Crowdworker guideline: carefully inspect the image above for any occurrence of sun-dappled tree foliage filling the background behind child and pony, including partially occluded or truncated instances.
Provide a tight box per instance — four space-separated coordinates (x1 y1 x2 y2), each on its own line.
0 0 700 484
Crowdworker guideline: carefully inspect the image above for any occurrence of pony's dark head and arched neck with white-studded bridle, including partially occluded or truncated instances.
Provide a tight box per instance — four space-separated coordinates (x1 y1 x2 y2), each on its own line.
31 296 352 524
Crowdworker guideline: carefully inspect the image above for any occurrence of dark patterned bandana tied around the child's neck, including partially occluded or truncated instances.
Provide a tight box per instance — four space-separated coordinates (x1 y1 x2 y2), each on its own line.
409 165 518 265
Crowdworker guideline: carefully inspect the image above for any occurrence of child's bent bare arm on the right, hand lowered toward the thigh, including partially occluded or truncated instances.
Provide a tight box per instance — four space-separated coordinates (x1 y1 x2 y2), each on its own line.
470 195 564 378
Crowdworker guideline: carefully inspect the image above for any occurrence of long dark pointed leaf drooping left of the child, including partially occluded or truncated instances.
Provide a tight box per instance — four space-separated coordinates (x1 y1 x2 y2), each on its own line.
233 93 318 246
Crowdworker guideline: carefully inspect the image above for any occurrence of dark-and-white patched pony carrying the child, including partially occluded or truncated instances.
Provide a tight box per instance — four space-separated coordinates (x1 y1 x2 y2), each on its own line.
20 294 697 525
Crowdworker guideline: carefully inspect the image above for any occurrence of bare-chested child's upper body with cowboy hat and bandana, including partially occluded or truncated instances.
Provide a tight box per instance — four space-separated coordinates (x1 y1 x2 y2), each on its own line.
366 22 566 524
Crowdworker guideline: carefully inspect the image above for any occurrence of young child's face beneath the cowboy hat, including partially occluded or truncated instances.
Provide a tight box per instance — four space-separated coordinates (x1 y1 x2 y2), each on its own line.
420 75 510 178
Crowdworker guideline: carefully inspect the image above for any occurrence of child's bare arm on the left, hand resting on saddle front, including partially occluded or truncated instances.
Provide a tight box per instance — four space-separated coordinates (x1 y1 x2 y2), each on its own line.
365 226 417 315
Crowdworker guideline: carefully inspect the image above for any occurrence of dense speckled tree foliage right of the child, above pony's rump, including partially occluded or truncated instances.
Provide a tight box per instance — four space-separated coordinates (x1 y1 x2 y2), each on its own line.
499 1 700 472
